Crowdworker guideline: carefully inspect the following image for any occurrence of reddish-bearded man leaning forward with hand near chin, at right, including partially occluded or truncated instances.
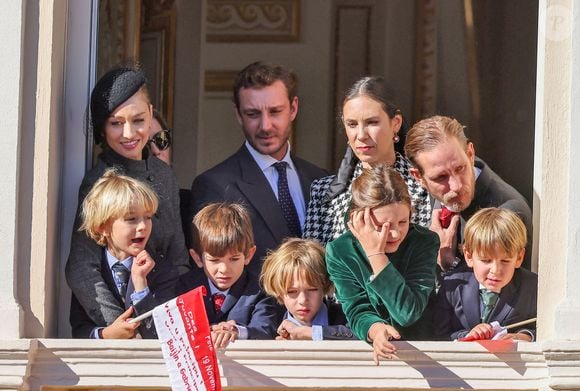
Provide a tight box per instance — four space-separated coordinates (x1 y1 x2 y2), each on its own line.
405 116 532 272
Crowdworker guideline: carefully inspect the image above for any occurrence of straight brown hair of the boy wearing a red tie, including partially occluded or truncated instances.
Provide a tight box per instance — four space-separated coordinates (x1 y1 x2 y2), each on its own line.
191 202 254 257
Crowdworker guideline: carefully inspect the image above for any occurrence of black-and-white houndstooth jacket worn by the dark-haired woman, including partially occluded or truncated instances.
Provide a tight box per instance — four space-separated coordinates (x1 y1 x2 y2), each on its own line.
302 153 431 244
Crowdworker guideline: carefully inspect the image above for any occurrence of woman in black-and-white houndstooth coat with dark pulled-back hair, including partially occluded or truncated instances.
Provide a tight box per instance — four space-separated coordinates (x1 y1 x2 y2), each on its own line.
303 76 431 244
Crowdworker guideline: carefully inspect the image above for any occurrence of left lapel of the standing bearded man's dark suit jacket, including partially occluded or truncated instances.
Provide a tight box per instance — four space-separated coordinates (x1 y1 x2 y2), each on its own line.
237 146 290 240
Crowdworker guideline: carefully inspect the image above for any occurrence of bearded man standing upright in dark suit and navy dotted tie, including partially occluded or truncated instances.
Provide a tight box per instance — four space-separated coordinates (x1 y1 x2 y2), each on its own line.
191 62 326 274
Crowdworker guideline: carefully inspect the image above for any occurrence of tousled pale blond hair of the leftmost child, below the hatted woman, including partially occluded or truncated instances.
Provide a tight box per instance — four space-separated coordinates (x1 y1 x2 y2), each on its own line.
79 168 159 246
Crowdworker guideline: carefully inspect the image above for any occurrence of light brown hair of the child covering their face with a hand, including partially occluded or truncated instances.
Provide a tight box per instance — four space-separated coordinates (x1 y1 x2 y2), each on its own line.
350 164 412 216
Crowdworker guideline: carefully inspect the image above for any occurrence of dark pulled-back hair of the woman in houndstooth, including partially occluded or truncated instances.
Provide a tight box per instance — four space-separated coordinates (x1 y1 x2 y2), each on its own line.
338 76 409 155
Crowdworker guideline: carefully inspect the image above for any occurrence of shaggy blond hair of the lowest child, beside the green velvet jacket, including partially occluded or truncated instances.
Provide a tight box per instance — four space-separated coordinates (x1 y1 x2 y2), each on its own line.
260 238 332 304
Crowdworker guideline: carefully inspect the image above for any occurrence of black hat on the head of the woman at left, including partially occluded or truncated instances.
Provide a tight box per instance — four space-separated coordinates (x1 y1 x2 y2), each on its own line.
90 66 149 146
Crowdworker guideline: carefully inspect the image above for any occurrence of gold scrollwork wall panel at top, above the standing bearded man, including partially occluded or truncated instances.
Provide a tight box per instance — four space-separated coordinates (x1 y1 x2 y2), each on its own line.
206 0 300 42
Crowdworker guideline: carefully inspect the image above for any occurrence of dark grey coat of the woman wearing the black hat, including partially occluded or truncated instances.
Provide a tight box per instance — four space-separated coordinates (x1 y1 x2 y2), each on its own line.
65 150 191 325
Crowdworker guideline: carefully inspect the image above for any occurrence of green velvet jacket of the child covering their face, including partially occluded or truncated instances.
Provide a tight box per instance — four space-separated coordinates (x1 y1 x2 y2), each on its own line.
326 226 439 340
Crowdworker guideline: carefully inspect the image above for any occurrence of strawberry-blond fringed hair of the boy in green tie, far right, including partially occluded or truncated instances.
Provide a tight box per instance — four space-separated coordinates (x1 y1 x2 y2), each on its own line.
463 208 527 257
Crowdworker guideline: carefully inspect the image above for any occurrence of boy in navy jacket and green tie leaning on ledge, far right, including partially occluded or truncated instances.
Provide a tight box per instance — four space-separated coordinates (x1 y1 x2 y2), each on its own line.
433 208 538 341
